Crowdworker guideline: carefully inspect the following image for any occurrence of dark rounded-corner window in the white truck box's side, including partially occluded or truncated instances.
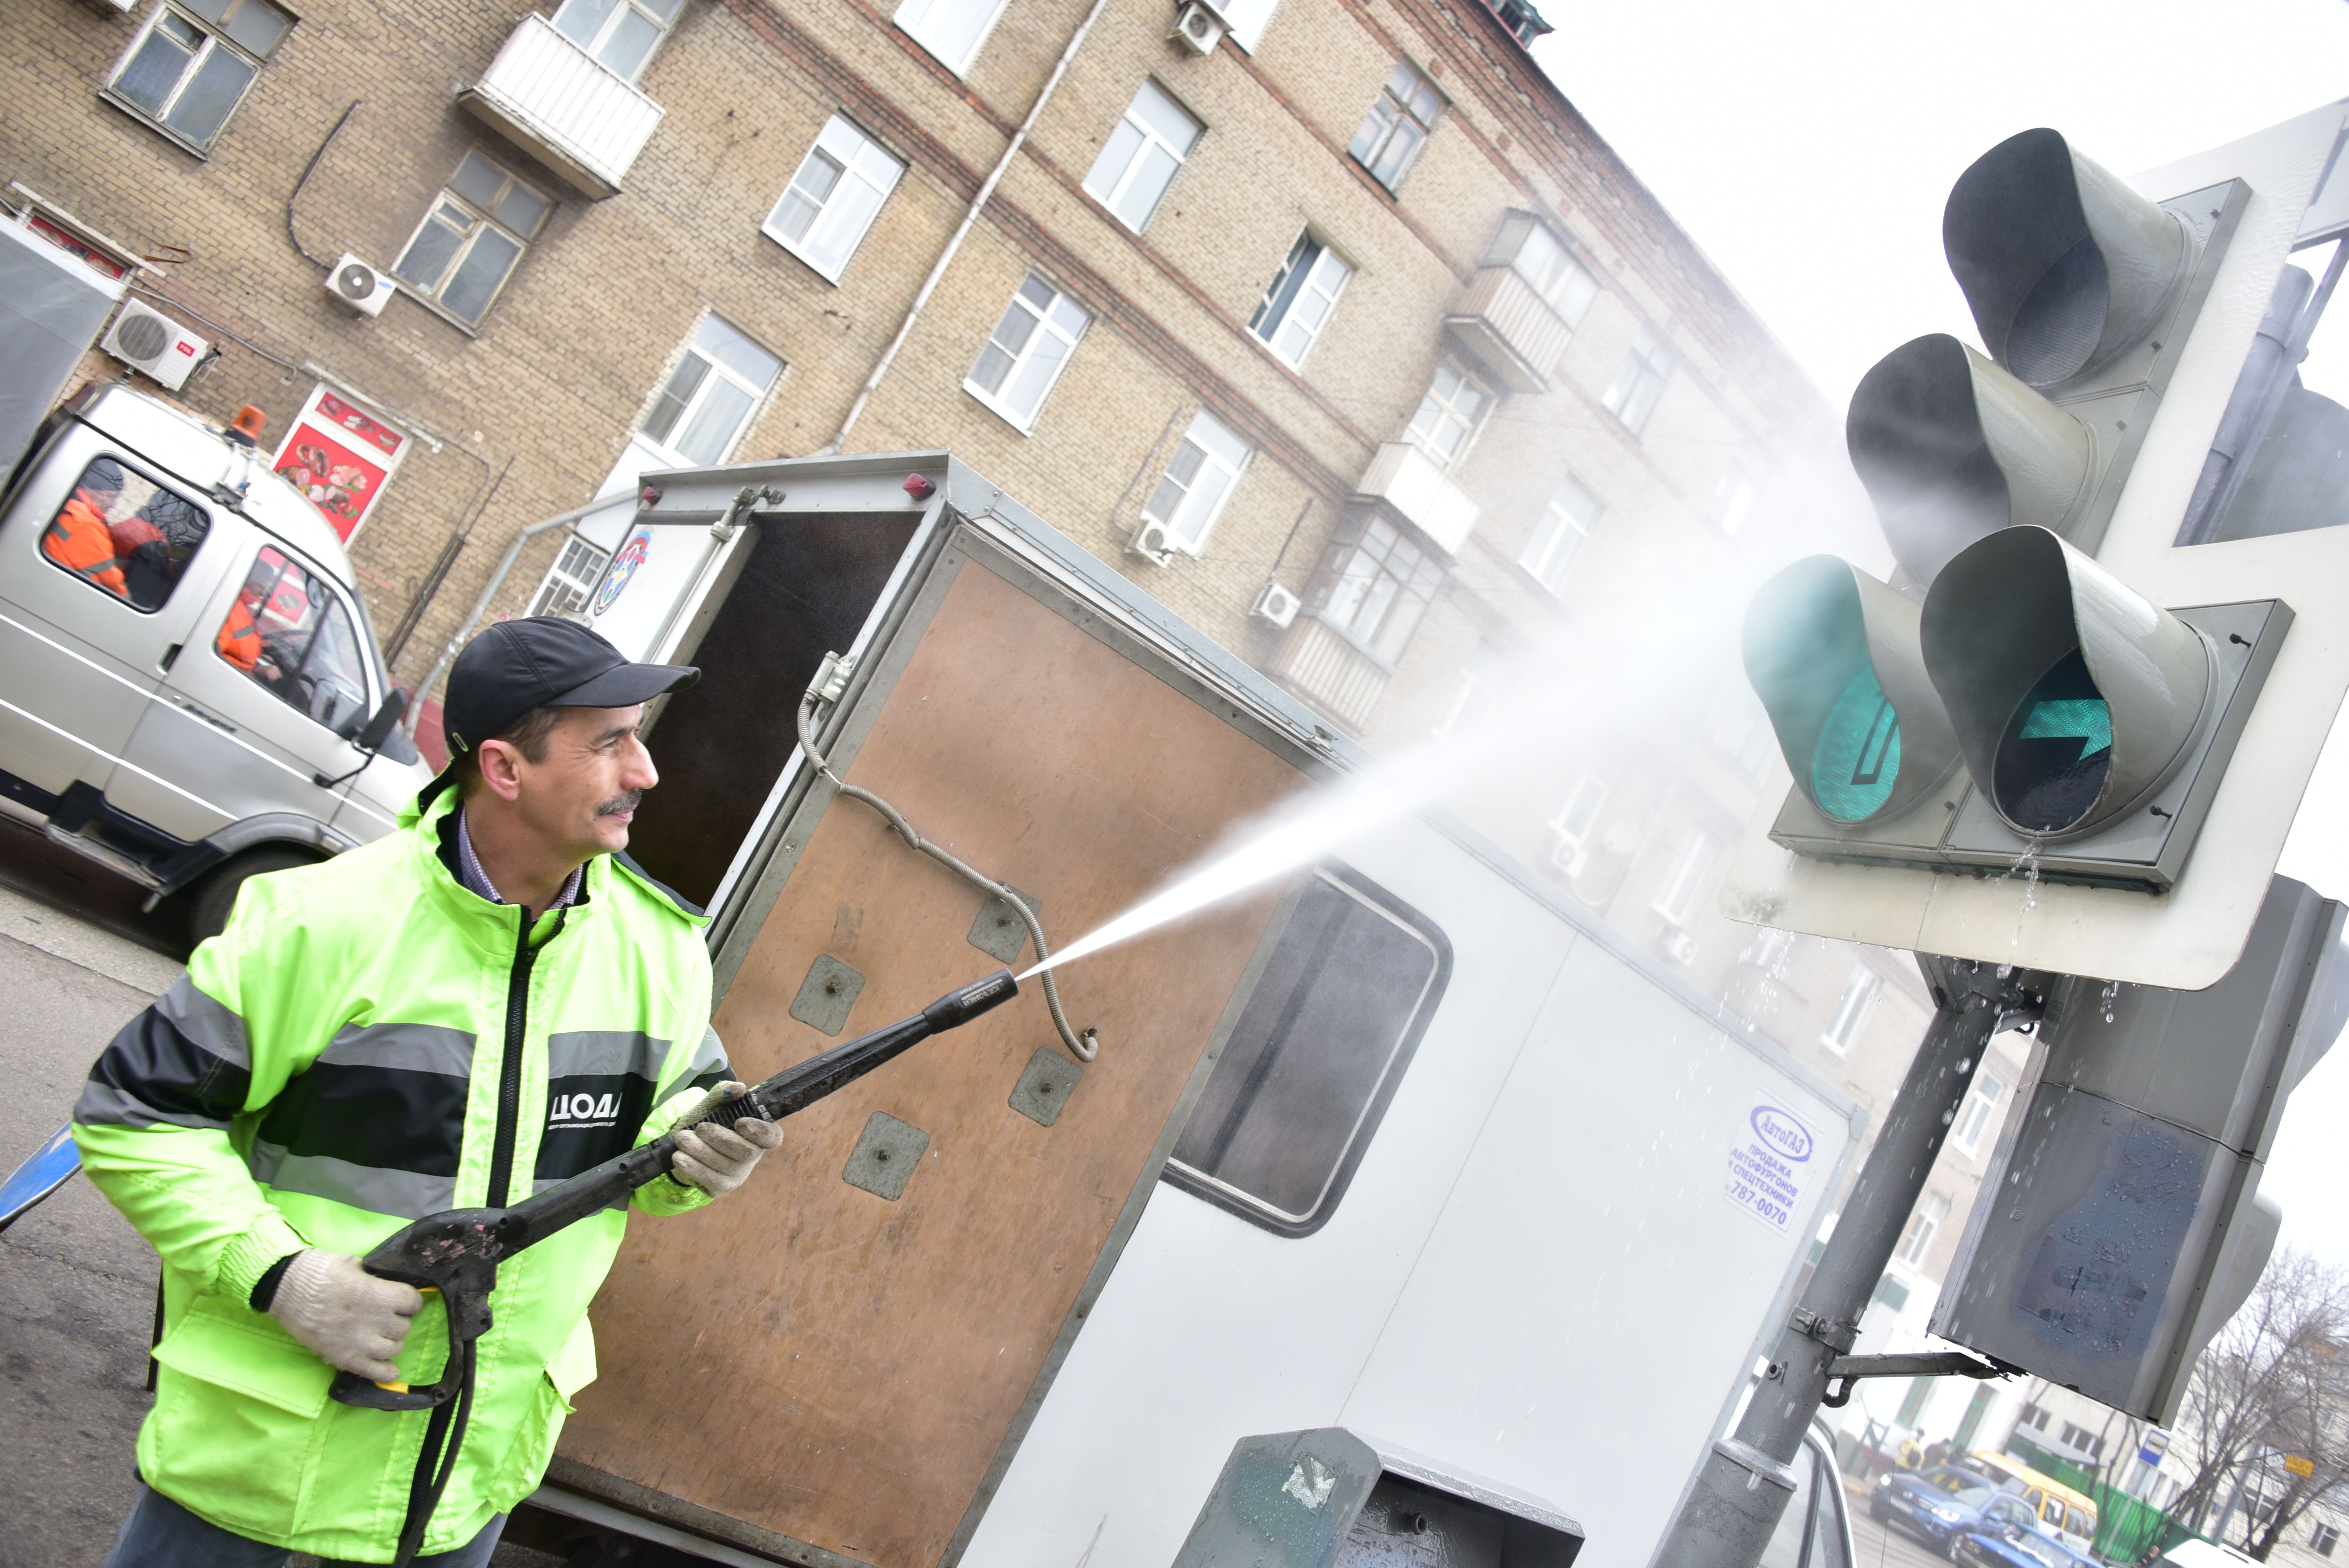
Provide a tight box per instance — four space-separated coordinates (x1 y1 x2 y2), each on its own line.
1167 868 1452 1235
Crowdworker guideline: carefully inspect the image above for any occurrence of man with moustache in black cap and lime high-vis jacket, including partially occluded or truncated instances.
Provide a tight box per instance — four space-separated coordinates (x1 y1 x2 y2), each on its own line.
73 617 780 1568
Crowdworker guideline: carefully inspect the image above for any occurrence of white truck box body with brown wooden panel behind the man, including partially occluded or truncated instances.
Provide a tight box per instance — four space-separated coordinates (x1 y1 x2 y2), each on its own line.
540 453 1856 1568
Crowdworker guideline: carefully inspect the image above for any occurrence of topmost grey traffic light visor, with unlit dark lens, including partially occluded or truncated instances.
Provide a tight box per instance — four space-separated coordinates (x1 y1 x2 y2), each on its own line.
1940 129 2196 387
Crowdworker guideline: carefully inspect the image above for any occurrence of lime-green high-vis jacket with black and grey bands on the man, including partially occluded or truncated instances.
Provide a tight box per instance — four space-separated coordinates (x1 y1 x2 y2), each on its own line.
73 791 728 1563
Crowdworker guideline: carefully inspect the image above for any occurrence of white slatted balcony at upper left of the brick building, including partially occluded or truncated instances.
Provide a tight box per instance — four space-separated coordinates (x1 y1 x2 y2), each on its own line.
456 12 663 202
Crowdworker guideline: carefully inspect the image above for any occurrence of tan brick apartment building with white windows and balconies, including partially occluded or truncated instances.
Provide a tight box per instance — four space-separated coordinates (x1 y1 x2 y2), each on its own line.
0 0 2013 1361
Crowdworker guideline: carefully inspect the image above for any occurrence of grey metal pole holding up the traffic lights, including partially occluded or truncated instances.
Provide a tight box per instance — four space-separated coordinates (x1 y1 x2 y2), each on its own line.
1654 955 2051 1568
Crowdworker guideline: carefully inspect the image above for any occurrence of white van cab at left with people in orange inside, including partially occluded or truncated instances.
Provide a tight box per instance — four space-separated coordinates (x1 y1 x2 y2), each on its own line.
0 385 430 939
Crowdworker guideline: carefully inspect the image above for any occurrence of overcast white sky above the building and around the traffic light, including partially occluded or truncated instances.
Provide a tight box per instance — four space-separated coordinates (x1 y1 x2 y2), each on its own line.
1534 0 2349 1267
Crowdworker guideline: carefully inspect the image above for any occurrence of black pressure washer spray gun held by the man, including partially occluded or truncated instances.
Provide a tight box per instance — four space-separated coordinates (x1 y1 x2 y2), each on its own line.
331 969 1019 1563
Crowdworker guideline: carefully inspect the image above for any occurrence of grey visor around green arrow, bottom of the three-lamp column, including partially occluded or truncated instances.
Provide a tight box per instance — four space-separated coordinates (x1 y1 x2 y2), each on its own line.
1921 528 2215 838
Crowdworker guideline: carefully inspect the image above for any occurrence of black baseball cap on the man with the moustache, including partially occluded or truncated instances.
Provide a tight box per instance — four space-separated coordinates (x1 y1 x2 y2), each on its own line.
442 615 702 758
